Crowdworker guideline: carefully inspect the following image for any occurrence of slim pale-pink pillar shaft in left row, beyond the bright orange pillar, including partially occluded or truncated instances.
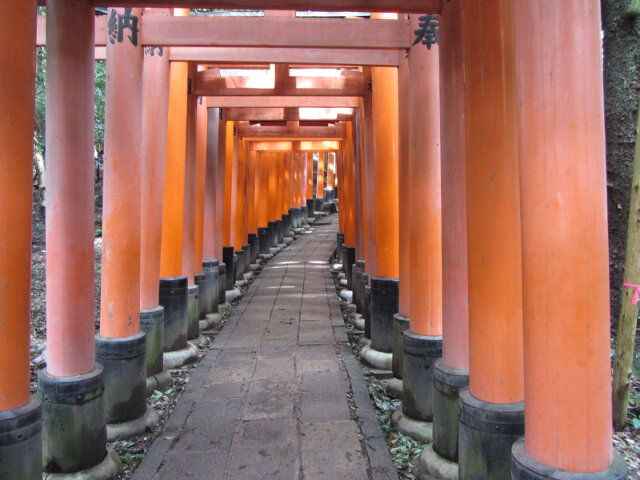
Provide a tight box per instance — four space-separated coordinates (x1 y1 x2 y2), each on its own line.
202 108 222 260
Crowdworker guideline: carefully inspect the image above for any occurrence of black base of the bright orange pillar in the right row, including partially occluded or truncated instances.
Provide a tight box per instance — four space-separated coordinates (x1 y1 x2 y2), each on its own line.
371 278 399 353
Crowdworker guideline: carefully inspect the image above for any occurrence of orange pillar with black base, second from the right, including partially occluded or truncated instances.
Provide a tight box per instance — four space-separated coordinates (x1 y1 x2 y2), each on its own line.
459 0 524 479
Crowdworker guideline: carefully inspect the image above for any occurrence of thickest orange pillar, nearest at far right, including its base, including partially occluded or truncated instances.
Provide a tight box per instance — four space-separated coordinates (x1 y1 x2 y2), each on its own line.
512 0 630 480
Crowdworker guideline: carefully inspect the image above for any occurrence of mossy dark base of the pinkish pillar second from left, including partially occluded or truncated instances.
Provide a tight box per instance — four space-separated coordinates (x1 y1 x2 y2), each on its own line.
38 364 107 477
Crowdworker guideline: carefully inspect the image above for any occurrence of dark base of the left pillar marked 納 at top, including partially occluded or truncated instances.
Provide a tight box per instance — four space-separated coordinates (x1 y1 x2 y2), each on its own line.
96 332 147 424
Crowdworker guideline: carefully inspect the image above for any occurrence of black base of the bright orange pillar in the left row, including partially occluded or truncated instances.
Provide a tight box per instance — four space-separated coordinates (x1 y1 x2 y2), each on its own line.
159 277 188 352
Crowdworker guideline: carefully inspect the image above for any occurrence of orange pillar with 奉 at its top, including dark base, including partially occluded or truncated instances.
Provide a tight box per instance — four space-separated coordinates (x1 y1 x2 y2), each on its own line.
402 15 442 421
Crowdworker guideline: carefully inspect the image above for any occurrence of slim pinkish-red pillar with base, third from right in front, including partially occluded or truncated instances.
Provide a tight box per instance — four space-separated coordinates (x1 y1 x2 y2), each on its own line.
433 2 469 460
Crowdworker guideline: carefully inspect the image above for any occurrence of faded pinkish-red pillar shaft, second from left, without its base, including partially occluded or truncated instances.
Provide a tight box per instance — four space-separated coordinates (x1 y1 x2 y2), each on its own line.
45 1 95 377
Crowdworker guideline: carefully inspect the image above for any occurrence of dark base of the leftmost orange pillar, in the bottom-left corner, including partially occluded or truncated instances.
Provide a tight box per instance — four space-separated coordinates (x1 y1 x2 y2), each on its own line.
0 398 42 480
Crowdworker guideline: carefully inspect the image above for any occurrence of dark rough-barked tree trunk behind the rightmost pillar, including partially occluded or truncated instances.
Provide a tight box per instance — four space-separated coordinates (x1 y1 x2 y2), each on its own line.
601 0 640 322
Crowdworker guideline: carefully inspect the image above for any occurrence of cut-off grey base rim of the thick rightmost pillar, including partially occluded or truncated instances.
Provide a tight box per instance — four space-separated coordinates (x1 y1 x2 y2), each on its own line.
511 438 629 480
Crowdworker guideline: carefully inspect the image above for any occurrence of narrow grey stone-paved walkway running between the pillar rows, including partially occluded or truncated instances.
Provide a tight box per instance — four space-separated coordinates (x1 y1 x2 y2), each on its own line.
133 215 397 480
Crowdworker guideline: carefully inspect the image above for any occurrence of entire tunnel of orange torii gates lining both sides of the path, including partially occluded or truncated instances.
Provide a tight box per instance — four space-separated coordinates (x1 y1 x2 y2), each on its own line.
0 0 633 479
